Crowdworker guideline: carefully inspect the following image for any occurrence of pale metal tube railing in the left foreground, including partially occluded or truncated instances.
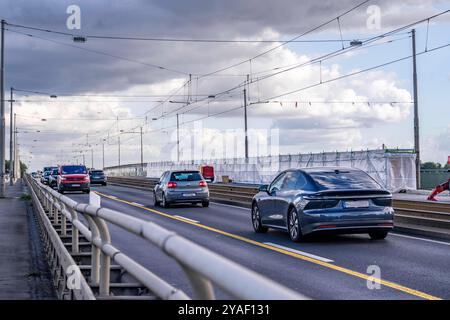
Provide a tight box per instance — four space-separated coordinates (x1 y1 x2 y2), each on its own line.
25 175 307 300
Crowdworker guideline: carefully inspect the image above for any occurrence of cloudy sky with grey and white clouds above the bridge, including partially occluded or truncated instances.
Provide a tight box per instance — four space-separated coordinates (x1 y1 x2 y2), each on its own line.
0 0 450 169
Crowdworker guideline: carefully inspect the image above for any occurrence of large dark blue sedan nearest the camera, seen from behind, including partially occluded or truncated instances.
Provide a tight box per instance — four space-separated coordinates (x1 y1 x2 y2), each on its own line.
251 167 394 241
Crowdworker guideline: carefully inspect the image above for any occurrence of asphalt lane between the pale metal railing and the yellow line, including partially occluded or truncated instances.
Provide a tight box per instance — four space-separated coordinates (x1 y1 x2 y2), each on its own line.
71 190 417 300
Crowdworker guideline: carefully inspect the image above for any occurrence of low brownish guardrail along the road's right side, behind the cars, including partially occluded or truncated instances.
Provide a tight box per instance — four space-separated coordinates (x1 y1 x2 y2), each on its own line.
108 176 450 239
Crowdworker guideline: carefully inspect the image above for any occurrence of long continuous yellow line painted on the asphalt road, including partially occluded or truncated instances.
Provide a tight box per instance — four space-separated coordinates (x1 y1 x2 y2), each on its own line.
97 192 442 300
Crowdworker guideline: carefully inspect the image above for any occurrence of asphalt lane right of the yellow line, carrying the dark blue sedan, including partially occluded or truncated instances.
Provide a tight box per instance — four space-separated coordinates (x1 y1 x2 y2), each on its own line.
89 186 450 299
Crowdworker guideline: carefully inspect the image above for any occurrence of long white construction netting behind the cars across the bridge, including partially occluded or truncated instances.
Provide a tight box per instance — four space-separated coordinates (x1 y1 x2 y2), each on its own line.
136 150 416 191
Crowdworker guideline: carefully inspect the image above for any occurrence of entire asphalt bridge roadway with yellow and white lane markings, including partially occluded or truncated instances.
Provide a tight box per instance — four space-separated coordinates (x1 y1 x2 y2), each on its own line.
67 182 450 299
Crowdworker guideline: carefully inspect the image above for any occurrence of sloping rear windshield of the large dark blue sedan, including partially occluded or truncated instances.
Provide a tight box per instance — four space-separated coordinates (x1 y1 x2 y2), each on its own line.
309 170 381 190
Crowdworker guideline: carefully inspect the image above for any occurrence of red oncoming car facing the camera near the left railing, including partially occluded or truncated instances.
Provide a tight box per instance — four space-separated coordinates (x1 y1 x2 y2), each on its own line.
57 165 91 193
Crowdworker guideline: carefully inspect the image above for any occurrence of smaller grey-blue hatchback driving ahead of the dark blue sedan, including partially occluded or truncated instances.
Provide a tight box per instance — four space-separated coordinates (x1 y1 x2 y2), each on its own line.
153 171 209 208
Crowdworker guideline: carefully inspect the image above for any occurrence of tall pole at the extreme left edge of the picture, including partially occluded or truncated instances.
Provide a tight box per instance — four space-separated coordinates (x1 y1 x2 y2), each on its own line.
0 20 5 198
